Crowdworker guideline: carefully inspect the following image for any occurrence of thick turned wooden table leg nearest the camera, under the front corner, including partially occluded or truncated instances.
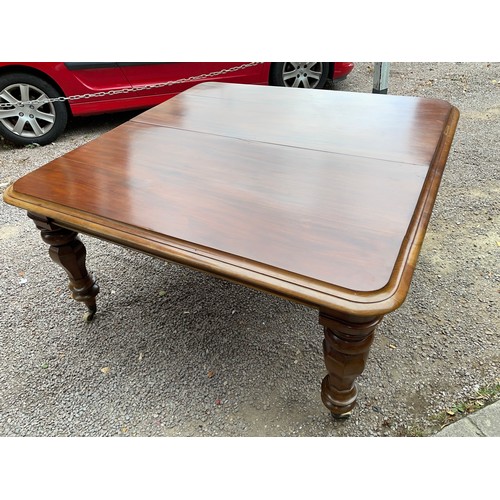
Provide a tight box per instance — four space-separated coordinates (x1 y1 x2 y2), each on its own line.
319 312 382 418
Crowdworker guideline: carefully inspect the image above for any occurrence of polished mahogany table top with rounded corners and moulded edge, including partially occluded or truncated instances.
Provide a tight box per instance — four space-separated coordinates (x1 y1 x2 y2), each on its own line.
4 83 458 315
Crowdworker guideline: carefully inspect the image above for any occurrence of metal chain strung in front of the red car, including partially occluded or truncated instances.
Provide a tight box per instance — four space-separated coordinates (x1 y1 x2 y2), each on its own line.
0 62 263 108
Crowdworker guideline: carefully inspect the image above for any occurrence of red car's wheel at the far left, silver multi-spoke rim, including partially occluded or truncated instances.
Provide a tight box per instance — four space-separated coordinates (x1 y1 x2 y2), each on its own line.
0 73 69 146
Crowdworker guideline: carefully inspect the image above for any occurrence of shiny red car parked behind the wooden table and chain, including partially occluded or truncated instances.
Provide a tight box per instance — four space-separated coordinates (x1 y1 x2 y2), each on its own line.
0 62 354 145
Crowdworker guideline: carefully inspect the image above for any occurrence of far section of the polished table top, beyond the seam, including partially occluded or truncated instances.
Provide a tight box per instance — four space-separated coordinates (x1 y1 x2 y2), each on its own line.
133 83 451 165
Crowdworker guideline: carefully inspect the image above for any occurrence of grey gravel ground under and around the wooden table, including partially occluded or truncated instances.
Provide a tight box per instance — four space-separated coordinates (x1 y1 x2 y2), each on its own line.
0 63 500 436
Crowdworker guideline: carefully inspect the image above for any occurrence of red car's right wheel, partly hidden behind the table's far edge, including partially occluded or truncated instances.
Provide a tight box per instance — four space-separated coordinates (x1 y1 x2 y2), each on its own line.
269 62 329 89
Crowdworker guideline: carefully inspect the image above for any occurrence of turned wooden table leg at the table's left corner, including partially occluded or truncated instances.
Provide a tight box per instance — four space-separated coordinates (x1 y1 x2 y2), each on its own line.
28 213 99 321
